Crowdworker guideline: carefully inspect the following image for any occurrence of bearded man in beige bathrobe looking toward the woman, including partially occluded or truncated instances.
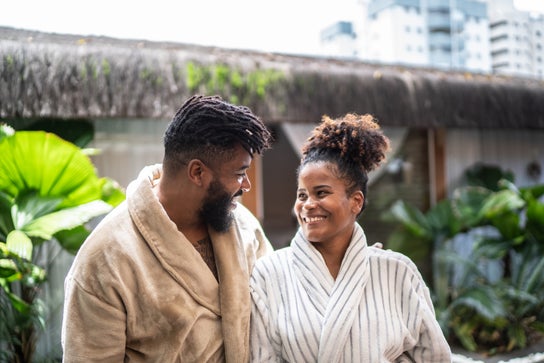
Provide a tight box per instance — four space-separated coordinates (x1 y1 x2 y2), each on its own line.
62 96 272 362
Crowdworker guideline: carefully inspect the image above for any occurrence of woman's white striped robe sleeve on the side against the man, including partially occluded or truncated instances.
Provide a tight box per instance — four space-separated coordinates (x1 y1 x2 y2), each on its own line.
249 267 282 363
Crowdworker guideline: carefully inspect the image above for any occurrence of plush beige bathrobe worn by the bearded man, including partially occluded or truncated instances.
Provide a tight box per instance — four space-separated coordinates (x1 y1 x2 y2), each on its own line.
62 166 272 363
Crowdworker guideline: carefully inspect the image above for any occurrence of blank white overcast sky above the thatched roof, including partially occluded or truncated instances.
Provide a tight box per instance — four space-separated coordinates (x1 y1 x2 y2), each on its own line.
0 0 544 54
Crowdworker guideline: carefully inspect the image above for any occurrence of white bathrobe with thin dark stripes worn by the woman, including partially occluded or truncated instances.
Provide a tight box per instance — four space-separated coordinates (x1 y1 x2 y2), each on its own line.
250 223 451 363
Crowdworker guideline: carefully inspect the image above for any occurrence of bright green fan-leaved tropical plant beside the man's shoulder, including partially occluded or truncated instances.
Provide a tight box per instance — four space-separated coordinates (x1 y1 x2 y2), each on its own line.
0 125 124 362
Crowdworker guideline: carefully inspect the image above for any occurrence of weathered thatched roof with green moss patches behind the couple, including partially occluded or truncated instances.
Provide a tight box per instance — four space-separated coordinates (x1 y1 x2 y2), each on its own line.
0 27 544 129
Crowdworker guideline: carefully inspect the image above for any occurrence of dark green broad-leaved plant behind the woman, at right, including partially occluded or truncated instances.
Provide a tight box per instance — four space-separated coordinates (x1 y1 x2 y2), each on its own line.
388 165 544 354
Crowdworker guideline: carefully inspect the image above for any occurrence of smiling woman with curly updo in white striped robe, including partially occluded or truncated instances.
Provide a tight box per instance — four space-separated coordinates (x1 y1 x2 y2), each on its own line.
250 114 451 363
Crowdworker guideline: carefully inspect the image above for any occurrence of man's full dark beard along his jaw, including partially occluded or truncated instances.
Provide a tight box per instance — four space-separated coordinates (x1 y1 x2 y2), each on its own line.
200 180 242 232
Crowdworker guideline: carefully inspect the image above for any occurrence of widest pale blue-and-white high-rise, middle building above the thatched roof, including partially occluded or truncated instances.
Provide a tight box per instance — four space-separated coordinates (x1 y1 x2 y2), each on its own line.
361 0 491 72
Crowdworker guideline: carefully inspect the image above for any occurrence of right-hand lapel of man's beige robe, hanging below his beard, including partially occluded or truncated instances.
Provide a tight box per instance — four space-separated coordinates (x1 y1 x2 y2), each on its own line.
209 223 251 363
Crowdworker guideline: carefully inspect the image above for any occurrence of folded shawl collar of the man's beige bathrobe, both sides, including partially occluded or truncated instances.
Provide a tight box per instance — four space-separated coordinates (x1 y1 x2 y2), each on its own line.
127 165 251 362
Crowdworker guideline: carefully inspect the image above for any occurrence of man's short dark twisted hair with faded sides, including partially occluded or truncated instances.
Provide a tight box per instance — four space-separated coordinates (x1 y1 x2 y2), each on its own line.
164 95 271 170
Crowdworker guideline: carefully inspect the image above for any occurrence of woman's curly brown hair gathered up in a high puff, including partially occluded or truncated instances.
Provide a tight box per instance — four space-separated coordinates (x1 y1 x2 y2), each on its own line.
298 113 389 213
